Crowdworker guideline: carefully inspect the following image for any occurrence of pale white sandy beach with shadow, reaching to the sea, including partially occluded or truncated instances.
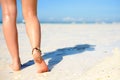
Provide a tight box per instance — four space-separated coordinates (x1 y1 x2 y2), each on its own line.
0 24 120 80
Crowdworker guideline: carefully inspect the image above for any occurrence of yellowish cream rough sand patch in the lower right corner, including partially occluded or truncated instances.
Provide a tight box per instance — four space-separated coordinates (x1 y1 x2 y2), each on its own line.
78 48 120 80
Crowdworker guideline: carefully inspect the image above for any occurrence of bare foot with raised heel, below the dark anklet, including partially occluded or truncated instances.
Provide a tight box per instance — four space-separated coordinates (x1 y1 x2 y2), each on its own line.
33 49 48 73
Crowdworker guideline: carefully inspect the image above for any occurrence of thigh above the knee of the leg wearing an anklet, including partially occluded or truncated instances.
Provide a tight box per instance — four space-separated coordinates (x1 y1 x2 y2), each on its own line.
22 0 37 17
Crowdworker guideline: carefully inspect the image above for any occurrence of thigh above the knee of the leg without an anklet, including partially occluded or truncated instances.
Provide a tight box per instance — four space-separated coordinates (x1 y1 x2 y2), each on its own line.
1 0 17 17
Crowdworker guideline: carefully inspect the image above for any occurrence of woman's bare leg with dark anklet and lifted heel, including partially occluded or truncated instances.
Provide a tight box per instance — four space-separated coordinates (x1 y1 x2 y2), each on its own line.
22 0 48 73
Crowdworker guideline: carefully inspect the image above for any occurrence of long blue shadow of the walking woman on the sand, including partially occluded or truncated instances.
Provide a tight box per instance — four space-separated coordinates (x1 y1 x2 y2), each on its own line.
22 44 95 70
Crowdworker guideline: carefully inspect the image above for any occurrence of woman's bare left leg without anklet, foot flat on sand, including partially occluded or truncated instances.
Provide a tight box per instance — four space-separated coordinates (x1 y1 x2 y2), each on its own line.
1 0 20 71
